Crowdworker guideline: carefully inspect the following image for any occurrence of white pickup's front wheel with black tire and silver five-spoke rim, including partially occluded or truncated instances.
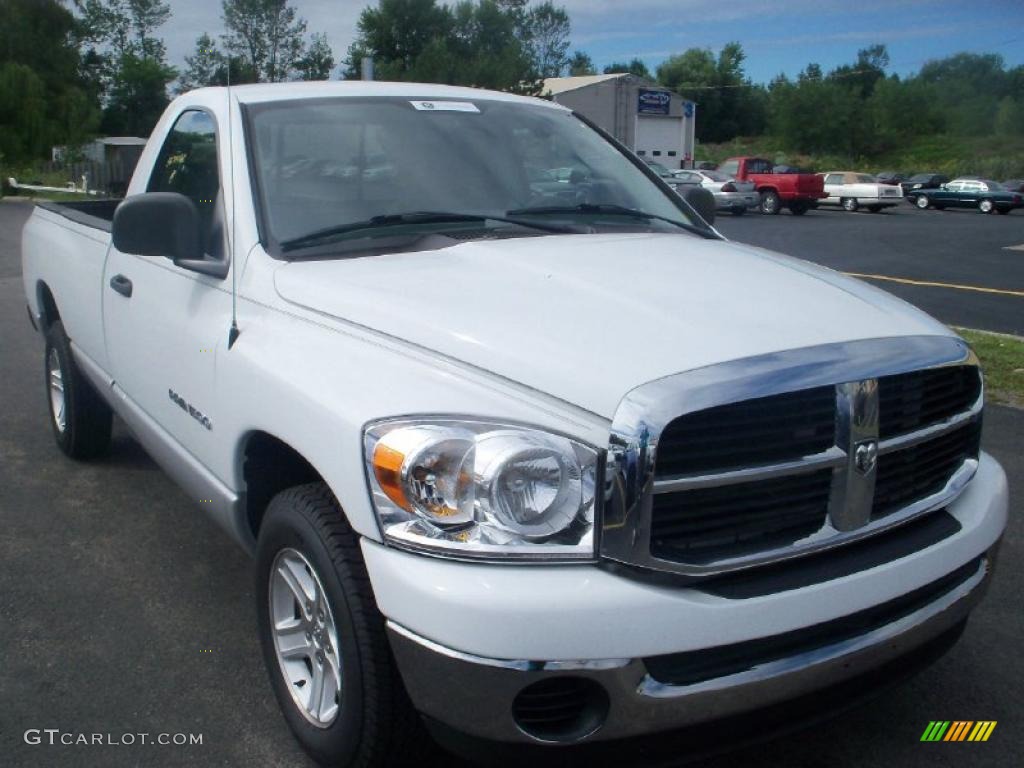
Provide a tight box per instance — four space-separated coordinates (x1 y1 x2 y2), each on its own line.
256 482 429 766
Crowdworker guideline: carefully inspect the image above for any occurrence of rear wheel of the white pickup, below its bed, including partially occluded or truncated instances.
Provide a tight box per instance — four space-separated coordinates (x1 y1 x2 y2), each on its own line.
44 321 114 460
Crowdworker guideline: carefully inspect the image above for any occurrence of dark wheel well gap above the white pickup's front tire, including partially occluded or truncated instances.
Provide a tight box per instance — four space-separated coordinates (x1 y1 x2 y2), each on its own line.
242 432 324 538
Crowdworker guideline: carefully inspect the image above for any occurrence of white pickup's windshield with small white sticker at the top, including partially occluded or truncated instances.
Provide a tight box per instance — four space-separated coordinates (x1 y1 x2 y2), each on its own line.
248 97 710 251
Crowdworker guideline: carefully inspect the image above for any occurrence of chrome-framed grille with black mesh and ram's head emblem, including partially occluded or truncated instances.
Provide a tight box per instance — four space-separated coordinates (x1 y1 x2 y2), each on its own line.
602 337 983 575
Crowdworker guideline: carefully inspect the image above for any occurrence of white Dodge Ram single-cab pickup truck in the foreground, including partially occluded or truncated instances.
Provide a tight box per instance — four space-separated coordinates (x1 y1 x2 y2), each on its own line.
24 82 1008 765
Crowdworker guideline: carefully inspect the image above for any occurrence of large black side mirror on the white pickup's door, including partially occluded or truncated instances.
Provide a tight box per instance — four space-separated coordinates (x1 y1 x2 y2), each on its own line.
111 193 228 279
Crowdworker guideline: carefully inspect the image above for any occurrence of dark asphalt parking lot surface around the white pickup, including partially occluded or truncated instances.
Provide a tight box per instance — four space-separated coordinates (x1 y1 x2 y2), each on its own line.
0 203 1024 768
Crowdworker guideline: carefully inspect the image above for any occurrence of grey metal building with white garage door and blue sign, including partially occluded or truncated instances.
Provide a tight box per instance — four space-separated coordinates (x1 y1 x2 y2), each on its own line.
542 73 696 168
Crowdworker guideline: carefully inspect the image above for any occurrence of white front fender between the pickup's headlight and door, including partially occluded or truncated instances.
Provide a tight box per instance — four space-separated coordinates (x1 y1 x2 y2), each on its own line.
216 304 609 541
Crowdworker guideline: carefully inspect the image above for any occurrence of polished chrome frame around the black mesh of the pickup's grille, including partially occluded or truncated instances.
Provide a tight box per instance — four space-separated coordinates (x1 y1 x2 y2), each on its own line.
600 336 983 577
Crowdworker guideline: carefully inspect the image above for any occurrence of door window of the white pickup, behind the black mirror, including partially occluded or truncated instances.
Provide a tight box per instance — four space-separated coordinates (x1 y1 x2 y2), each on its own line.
146 110 223 257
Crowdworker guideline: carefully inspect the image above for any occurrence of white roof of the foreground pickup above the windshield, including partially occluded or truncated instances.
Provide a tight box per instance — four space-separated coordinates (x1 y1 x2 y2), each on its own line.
182 80 565 110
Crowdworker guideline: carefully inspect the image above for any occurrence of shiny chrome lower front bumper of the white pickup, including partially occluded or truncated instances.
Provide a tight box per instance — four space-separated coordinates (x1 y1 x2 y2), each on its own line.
388 547 995 744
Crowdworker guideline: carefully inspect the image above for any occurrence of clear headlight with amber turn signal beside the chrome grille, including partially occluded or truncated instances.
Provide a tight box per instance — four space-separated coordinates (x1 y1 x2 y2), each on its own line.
364 419 598 559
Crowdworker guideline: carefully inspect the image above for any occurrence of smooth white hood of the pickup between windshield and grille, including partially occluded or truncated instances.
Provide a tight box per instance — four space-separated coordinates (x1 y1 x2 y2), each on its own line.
274 233 950 418
